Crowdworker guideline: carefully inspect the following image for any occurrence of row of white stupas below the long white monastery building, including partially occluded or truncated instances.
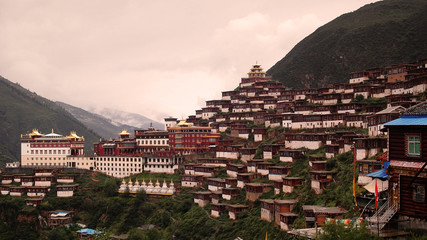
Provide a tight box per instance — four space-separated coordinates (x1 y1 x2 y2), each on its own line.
119 179 176 195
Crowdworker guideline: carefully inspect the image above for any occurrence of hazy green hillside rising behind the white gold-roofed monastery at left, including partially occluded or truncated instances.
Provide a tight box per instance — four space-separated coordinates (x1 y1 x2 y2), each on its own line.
0 77 99 167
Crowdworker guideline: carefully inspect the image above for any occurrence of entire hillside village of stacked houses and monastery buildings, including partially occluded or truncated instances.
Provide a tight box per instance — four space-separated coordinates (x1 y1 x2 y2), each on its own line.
1 60 427 238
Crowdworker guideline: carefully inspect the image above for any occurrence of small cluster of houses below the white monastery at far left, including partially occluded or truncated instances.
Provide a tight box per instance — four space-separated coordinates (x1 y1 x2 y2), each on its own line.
0 168 79 206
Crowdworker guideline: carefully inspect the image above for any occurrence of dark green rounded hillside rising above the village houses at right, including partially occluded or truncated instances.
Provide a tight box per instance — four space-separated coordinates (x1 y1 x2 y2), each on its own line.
267 0 427 88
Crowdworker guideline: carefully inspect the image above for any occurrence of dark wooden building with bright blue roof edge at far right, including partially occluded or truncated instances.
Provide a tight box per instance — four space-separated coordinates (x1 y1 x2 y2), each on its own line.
384 101 427 229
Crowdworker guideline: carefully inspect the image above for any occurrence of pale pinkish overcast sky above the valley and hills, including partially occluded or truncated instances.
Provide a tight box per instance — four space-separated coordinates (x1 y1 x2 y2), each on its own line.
0 0 380 121
